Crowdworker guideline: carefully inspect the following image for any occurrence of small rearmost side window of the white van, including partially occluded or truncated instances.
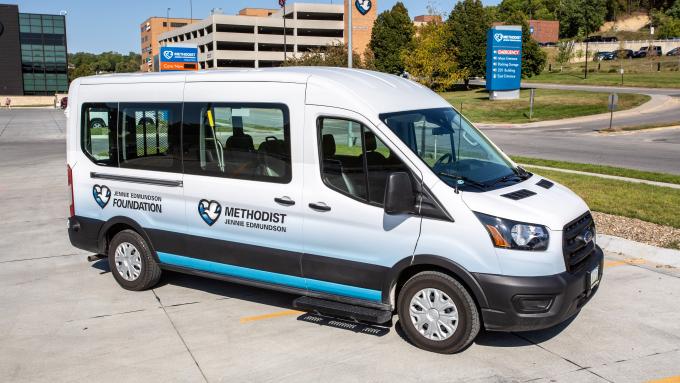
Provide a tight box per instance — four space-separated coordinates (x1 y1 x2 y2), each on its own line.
81 103 118 166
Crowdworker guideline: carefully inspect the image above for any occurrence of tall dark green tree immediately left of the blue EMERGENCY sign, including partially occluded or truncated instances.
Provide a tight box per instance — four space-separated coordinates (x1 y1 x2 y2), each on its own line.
446 0 490 87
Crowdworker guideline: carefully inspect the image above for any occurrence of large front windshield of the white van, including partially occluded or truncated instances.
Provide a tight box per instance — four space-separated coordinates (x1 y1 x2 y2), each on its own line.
380 108 527 191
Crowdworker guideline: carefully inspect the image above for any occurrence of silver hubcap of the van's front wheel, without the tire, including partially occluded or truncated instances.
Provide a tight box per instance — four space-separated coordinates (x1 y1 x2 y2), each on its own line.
409 288 458 341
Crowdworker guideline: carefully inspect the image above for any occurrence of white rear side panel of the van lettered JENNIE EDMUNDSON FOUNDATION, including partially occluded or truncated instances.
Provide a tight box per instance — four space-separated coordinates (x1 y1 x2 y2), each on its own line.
68 82 185 260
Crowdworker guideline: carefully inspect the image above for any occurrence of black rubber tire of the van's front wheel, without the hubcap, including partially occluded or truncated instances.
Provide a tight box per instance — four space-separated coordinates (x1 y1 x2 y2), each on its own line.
397 271 481 354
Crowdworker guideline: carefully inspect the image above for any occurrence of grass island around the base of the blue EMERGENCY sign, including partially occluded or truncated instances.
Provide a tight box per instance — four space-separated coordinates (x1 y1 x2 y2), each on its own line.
441 86 652 124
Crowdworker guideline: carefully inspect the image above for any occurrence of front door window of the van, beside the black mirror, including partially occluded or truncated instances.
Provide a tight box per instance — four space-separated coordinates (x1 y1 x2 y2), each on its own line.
318 118 410 205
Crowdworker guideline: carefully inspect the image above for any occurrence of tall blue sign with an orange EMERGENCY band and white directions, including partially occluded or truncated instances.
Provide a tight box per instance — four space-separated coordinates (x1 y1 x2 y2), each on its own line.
486 25 522 91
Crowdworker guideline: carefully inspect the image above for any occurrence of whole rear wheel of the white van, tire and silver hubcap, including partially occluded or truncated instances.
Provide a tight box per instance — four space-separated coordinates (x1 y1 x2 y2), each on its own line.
108 230 161 291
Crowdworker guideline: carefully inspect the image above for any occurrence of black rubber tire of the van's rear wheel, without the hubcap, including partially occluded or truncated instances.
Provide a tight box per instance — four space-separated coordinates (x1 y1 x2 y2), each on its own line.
108 230 161 291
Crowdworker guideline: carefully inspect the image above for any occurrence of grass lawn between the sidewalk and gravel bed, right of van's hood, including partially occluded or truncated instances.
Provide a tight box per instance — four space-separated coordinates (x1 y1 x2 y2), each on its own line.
527 167 680 228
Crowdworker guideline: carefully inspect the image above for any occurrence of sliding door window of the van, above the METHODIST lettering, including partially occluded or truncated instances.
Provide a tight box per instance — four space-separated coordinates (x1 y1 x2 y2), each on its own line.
183 103 292 183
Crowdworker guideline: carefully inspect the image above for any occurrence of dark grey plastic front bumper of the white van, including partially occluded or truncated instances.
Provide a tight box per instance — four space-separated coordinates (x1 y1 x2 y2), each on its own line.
473 246 604 331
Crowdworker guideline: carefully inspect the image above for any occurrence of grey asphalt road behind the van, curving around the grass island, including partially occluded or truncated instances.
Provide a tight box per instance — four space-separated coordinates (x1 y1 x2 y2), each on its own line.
468 82 680 174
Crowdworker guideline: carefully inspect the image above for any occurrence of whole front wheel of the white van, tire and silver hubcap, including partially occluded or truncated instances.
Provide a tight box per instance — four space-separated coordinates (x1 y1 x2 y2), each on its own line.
397 271 480 354
